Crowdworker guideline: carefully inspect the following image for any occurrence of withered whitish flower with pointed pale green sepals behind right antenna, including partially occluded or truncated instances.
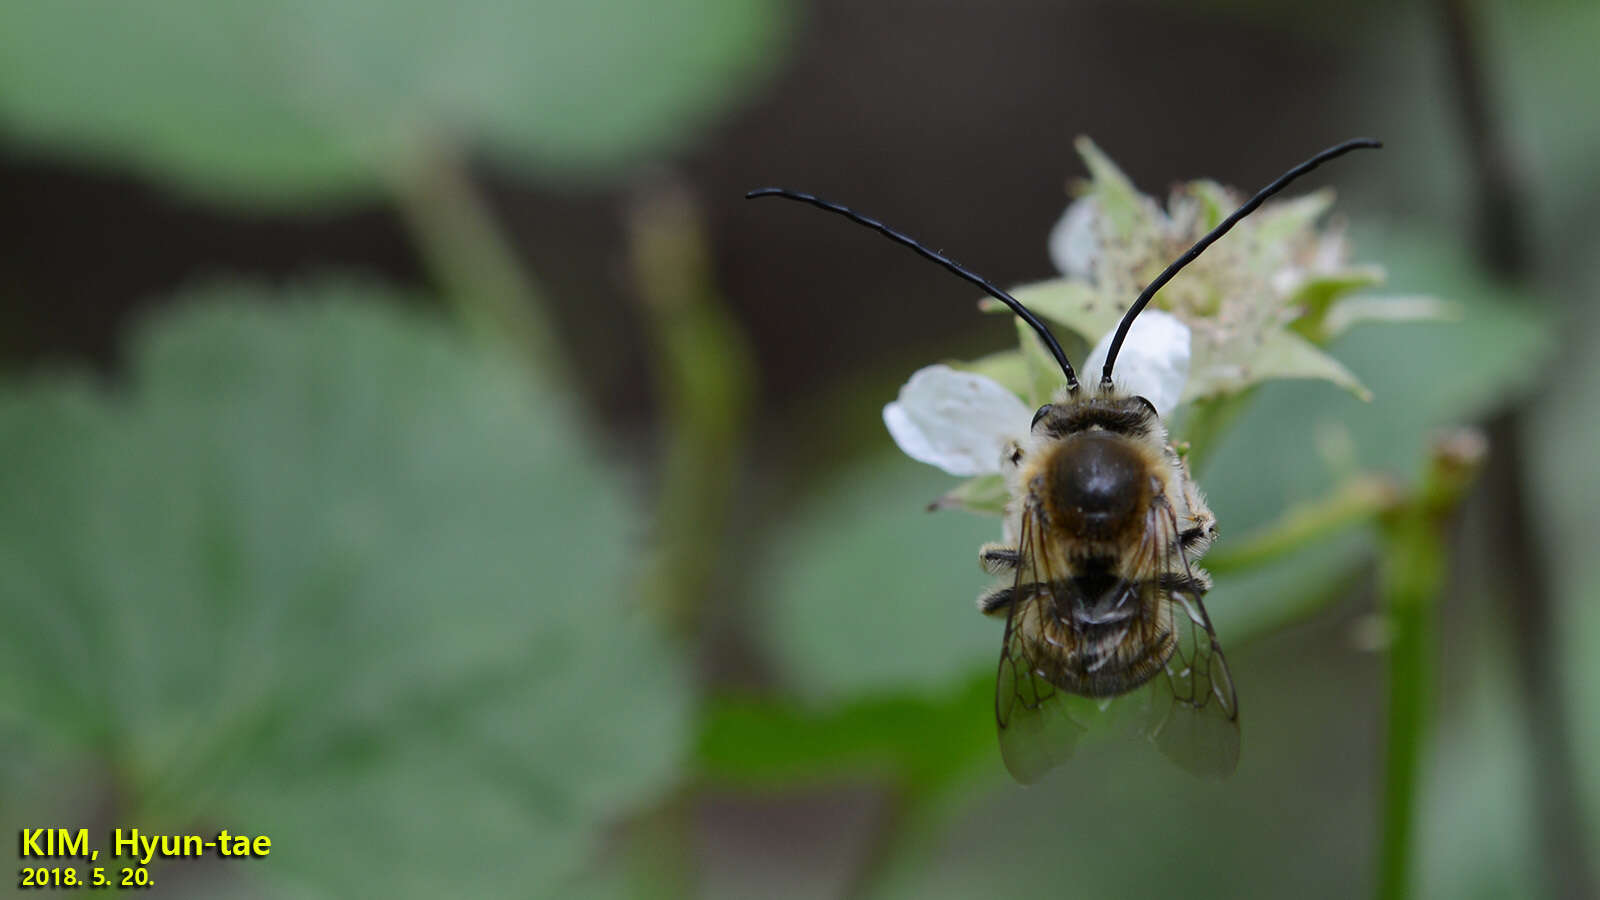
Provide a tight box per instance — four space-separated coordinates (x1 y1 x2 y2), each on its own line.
1017 138 1451 403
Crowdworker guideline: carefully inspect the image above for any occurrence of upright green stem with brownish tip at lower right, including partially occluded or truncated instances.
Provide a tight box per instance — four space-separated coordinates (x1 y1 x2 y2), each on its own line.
1378 431 1485 900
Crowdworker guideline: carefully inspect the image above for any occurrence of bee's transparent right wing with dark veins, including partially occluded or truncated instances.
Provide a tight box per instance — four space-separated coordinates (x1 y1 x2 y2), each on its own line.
1144 503 1238 778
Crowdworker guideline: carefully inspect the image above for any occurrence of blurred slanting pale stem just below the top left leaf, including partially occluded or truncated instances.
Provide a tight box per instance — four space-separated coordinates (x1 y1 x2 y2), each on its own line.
389 144 573 388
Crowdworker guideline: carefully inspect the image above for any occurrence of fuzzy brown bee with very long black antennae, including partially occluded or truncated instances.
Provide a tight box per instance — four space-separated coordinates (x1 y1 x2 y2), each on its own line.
746 138 1382 783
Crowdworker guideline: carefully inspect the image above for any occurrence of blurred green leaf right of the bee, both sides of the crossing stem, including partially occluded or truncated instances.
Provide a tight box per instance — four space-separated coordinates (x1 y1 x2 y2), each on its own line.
1164 224 1547 679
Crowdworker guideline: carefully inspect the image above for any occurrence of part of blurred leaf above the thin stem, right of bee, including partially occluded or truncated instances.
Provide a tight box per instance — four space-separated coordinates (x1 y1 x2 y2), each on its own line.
1198 225 1549 531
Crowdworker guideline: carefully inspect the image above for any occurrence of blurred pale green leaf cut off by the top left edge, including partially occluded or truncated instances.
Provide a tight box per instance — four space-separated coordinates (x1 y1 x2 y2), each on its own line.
0 0 784 202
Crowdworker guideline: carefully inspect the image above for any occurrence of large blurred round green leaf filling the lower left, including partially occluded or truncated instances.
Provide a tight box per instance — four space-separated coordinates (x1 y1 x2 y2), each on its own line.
0 285 691 897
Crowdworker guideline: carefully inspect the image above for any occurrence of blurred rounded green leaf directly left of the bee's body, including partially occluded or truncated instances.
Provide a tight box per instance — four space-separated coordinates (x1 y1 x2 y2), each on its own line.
757 453 1000 698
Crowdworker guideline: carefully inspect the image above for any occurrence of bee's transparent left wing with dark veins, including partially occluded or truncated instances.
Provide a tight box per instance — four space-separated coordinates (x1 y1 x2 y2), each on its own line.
995 499 1086 785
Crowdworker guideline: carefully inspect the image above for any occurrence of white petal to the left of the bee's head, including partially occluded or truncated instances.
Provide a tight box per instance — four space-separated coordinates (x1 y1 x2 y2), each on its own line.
883 365 1034 476
